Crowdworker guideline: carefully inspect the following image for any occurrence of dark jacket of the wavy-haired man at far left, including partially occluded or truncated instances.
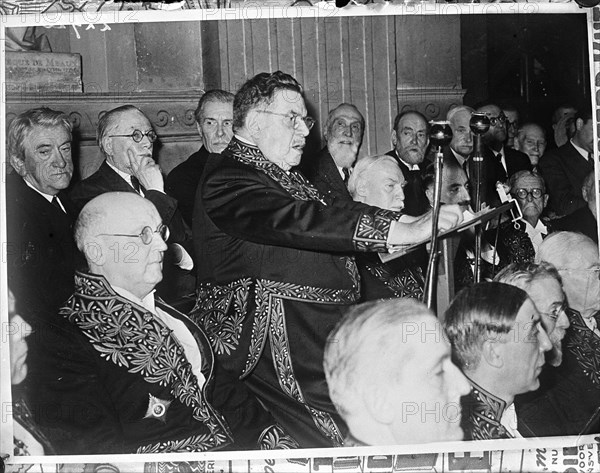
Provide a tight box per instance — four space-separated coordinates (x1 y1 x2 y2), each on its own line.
6 173 81 323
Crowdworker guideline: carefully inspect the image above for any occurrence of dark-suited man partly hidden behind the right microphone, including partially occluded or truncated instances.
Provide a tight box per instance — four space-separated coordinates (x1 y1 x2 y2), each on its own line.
477 104 531 184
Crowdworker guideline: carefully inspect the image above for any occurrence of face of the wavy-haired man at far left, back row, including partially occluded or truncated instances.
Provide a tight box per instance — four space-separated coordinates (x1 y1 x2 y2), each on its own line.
17 126 73 195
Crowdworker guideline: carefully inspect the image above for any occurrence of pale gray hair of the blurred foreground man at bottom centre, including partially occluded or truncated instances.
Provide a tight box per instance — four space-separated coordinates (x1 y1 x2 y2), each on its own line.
323 299 433 418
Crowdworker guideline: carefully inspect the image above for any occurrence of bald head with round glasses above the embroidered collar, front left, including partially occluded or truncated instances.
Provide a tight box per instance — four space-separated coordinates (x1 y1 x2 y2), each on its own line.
75 192 167 298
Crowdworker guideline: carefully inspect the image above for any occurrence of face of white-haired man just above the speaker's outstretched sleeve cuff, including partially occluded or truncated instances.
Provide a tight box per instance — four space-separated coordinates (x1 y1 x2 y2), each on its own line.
361 161 405 211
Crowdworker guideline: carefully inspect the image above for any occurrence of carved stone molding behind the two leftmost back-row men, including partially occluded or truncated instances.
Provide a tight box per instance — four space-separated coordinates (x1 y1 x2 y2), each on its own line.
6 91 202 146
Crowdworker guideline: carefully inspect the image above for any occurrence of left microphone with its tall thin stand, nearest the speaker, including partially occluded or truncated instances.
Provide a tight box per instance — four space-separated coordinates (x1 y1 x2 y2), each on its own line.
424 121 452 312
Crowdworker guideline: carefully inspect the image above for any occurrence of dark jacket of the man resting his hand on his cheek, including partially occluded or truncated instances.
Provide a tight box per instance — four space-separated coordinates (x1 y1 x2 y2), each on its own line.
70 161 188 243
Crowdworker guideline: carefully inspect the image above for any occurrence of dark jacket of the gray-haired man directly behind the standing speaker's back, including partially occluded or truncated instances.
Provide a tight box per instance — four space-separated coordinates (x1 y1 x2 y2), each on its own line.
165 146 210 228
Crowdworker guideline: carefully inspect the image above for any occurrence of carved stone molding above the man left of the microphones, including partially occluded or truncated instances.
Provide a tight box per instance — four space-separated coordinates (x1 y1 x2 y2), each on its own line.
396 87 467 120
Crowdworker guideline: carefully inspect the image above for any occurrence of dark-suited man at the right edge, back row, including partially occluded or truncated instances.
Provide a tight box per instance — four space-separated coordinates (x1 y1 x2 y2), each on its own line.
539 107 596 216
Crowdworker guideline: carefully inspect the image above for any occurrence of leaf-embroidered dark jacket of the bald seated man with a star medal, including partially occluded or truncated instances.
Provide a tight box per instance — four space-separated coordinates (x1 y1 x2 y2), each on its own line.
32 273 294 454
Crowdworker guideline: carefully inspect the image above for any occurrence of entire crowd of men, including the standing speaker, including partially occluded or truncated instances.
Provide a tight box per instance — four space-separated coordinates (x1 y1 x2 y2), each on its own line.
6 71 600 455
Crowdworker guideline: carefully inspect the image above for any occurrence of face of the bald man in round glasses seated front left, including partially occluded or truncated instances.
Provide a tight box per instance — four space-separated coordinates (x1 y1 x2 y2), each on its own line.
100 198 167 298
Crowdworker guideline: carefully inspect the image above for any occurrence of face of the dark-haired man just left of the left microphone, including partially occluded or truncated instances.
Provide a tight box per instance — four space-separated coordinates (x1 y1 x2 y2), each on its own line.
392 113 429 164
